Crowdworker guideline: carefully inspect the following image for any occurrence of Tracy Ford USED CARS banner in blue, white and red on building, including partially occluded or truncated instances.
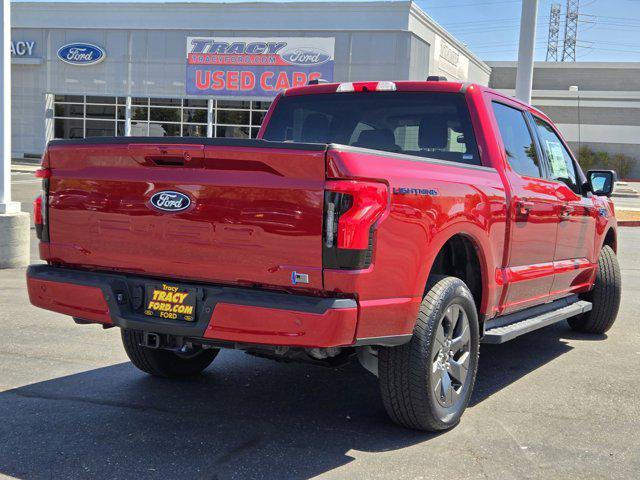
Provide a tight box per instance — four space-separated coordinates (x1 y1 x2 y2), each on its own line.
186 37 335 97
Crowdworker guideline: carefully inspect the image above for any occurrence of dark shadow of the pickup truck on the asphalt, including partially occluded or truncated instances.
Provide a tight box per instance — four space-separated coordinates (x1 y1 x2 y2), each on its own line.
0 324 587 479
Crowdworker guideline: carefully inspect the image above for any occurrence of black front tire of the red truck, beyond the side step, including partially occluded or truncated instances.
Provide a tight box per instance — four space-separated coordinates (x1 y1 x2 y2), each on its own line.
567 245 622 334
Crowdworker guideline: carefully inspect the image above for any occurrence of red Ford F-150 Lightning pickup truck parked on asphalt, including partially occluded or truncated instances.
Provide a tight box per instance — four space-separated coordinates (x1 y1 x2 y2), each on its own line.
27 81 621 431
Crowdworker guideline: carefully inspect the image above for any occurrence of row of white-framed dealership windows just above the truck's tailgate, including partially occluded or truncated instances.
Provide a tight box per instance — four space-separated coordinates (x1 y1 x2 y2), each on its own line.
53 95 270 138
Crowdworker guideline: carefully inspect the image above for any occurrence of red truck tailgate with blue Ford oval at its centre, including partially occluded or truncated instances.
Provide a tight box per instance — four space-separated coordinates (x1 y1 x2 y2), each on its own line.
48 138 326 288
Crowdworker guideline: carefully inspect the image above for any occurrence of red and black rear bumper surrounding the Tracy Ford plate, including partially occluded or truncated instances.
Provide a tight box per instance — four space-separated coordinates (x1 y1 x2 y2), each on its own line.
27 265 358 348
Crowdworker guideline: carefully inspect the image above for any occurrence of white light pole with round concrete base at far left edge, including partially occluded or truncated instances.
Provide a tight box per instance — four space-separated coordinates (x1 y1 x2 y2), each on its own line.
0 0 29 268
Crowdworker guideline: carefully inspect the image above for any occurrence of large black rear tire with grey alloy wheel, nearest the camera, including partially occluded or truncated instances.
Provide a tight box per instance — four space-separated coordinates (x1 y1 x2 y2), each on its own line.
378 276 479 432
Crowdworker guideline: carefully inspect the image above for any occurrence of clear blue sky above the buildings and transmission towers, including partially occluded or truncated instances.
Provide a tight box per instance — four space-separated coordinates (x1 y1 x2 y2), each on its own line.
14 0 640 62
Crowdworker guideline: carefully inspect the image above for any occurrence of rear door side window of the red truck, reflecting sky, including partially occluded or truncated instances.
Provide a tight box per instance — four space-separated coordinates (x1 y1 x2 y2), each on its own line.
493 102 542 178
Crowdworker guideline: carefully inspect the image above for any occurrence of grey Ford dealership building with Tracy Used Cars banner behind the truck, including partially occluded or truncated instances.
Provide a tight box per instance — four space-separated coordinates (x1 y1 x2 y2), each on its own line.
11 1 490 157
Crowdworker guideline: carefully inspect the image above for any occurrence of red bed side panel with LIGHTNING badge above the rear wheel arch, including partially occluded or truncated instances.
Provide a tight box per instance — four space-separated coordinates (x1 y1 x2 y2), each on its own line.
324 146 506 338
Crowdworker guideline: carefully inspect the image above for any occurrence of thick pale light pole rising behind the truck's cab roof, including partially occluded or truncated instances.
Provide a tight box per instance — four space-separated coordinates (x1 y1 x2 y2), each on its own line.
516 0 538 103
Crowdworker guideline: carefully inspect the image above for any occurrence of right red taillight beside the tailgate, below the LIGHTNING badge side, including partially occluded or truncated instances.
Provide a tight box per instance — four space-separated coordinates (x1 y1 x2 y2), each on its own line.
322 180 389 269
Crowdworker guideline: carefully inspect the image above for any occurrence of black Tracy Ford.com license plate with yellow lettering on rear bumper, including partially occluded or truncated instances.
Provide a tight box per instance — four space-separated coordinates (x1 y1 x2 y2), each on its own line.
143 282 197 323
